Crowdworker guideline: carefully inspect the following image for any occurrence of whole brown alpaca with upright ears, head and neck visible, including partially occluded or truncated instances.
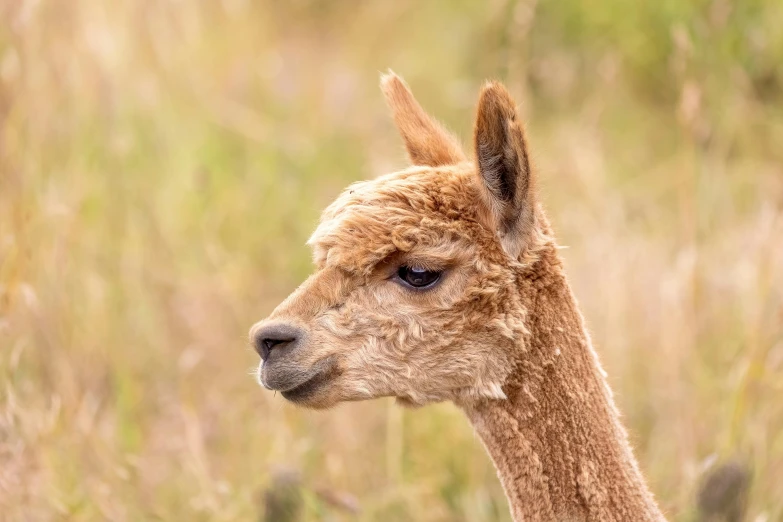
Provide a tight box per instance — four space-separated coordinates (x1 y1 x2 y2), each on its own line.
250 74 663 522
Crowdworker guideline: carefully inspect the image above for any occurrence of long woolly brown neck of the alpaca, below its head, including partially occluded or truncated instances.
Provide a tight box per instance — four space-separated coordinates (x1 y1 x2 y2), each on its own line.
461 253 663 521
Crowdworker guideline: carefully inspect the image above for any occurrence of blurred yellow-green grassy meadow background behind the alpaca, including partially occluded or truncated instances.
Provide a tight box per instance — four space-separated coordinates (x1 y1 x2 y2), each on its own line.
0 0 783 522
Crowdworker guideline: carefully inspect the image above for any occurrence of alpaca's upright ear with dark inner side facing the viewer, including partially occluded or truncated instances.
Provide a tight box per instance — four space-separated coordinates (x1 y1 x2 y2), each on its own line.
474 82 535 258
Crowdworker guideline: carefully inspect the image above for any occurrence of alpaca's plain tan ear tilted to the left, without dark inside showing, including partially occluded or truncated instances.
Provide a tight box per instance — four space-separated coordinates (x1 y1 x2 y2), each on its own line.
381 71 466 167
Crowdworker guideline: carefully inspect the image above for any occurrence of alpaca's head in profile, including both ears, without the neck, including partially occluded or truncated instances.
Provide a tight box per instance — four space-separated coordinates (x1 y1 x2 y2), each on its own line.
250 74 546 408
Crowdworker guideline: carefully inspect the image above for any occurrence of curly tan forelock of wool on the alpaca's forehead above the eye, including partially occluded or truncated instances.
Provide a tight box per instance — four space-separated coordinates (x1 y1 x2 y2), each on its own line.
308 164 482 275
